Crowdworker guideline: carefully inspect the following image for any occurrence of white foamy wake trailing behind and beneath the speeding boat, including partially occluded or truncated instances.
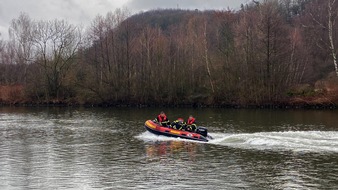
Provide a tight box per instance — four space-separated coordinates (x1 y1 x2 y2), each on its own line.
137 131 338 152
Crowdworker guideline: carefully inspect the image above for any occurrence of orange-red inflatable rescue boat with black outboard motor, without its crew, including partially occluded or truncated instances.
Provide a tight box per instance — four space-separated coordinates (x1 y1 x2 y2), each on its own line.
144 120 212 142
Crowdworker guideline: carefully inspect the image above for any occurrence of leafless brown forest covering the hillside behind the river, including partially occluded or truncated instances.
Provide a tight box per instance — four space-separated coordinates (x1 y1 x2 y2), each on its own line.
0 0 338 106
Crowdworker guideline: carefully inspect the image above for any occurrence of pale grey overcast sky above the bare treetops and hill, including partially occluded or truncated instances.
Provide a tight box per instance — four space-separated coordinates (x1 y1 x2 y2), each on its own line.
0 0 251 39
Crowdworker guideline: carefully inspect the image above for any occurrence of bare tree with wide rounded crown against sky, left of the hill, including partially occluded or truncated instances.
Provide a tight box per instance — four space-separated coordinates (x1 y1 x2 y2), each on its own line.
32 20 82 99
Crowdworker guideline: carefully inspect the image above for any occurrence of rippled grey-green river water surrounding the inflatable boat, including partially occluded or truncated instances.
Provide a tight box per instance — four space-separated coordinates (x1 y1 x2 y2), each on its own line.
0 107 338 189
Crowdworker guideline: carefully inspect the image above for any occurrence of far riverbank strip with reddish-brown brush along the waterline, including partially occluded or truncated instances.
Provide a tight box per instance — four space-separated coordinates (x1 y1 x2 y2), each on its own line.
0 85 338 109
